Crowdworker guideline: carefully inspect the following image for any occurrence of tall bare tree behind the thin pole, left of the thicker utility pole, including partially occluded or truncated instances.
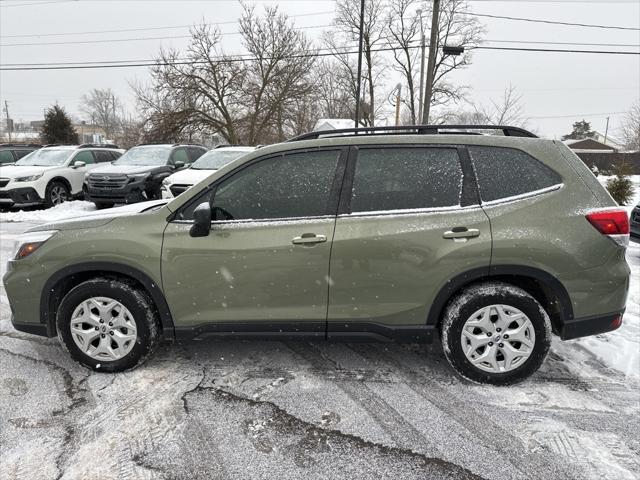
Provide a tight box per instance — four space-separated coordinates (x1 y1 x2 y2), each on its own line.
325 0 386 126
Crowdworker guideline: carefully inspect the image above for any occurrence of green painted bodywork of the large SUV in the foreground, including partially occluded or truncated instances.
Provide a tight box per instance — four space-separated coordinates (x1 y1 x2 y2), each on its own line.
4 135 629 339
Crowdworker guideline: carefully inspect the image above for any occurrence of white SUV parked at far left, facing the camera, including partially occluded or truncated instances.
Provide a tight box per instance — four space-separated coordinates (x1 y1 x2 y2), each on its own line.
0 144 124 208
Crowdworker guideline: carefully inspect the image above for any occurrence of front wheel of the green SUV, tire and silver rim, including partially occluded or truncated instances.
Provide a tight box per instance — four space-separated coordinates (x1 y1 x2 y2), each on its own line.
56 278 160 372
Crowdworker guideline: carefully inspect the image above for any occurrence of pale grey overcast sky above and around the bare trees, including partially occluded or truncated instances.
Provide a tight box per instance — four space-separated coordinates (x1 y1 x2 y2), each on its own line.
0 0 640 137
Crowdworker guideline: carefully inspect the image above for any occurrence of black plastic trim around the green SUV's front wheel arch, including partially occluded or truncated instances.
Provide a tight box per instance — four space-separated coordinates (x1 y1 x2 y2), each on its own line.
40 262 175 338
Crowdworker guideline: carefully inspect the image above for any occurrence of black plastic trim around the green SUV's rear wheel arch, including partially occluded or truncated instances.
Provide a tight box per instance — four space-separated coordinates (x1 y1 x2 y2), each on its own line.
427 265 573 325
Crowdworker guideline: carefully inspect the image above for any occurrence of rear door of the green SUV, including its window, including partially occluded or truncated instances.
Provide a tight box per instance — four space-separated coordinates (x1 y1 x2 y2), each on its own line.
328 145 491 335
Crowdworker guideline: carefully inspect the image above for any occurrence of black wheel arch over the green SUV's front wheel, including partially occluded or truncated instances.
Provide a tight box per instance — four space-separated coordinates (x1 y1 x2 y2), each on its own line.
40 262 175 338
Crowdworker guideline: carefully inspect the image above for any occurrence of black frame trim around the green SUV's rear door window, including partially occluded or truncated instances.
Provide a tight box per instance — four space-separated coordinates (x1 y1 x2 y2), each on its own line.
338 143 480 218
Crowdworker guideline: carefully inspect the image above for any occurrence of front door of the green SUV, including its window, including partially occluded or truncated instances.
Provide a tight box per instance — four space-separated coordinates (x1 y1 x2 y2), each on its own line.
162 149 348 335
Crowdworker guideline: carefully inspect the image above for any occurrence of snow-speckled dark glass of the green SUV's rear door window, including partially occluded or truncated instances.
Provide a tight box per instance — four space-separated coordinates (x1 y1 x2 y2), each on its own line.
351 147 462 213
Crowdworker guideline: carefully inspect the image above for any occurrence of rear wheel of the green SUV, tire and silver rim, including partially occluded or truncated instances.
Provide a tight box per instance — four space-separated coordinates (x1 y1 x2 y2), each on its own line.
440 282 551 385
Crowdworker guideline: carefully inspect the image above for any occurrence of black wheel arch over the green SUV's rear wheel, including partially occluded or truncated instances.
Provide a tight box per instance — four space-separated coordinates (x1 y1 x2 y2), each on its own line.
427 265 573 333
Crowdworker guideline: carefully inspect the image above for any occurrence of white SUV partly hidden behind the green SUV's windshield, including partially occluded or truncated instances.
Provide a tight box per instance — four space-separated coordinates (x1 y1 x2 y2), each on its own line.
162 146 256 198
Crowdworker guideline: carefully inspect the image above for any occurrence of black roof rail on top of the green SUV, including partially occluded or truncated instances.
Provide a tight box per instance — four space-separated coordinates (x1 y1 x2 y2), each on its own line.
287 125 538 142
